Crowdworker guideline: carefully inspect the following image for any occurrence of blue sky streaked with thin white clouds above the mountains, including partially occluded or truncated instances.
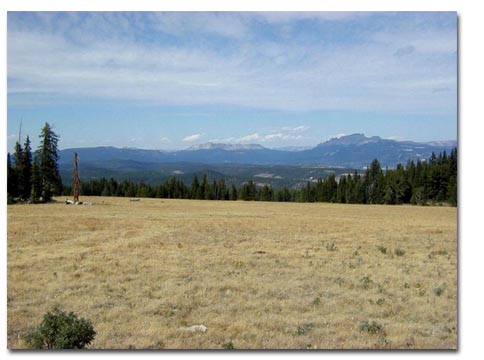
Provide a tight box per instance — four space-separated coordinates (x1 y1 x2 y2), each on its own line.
7 12 457 151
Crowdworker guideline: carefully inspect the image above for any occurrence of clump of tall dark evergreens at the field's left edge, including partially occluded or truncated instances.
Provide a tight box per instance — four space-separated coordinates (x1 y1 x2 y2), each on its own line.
7 123 63 204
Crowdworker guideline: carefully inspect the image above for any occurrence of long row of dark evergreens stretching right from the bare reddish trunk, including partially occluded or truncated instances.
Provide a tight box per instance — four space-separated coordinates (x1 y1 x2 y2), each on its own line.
63 148 457 206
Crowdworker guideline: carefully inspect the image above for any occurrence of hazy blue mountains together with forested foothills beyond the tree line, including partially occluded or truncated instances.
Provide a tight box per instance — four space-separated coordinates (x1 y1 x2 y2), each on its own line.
59 134 457 188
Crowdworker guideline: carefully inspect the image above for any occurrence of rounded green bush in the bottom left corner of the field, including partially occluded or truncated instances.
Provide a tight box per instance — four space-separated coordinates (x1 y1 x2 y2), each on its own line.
25 306 96 349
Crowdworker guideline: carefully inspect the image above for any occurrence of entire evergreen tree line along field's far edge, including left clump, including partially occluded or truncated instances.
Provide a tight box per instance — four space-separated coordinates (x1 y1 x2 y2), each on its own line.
7 123 457 206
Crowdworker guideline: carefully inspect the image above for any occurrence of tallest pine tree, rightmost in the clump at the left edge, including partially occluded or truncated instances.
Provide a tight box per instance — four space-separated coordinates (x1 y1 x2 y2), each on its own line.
38 123 62 202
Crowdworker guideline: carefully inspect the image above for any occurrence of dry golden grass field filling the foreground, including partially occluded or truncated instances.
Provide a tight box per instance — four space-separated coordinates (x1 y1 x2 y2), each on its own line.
7 198 457 349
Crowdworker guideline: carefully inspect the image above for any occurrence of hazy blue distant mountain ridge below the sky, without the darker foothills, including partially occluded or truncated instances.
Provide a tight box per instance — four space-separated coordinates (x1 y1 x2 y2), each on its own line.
59 134 457 169
